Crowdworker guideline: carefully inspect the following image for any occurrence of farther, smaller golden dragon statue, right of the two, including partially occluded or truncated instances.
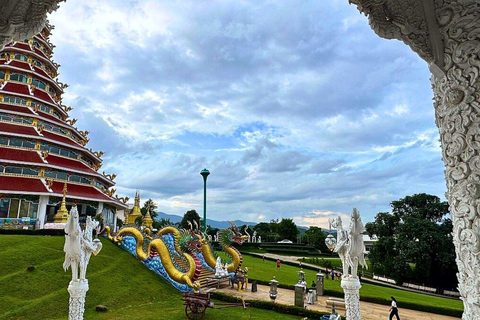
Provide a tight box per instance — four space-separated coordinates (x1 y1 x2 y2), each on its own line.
198 221 247 272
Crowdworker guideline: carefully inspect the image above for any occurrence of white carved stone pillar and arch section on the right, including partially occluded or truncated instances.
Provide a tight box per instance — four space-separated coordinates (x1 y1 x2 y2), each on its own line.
350 0 480 320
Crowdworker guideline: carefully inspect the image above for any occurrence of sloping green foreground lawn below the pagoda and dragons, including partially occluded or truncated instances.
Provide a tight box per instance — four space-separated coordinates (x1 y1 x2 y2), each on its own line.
0 235 300 320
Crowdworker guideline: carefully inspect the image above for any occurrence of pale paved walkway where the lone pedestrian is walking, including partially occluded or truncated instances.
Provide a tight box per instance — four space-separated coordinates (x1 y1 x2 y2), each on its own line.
214 285 459 320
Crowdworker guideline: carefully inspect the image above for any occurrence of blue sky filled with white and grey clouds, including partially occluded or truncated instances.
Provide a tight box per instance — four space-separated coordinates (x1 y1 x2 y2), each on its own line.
50 0 445 227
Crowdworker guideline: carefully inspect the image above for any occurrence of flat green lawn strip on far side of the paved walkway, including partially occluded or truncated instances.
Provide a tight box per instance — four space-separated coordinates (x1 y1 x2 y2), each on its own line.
238 255 463 311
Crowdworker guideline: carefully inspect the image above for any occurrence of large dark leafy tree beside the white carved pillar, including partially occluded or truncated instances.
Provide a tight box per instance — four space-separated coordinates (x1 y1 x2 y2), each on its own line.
365 193 457 289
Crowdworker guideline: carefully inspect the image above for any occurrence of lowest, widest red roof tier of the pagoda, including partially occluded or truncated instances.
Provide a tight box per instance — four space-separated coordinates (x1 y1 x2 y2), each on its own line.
0 175 128 209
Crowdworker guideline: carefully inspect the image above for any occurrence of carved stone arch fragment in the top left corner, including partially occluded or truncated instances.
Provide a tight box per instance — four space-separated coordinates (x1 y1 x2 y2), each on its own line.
0 0 65 50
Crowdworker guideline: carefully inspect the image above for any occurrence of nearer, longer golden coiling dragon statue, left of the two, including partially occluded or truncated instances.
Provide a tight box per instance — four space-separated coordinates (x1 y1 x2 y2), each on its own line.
102 226 206 291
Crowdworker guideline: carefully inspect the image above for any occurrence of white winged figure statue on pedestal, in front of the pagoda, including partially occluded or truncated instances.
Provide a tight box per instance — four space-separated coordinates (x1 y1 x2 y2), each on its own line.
63 206 102 320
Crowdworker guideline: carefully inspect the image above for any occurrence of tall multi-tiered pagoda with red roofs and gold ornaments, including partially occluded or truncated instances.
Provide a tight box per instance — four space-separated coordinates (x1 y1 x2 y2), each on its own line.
0 26 128 229
